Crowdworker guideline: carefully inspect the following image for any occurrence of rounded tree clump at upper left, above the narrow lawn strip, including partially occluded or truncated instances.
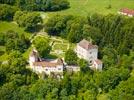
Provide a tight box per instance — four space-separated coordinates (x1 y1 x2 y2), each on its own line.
14 11 42 32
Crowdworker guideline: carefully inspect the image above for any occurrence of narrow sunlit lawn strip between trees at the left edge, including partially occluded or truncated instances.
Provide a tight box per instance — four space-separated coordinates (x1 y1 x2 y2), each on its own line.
0 21 31 37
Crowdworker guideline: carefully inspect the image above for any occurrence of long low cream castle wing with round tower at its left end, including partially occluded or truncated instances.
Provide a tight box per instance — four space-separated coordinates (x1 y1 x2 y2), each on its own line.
29 50 64 77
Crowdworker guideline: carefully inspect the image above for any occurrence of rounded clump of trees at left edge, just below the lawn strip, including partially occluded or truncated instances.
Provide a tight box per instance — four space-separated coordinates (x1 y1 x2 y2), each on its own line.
0 30 30 53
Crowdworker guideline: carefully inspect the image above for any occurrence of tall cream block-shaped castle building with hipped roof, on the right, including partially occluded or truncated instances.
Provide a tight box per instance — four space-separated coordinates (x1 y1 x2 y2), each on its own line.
75 39 102 70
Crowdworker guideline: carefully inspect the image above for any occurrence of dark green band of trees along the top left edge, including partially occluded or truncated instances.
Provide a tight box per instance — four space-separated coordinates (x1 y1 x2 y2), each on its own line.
0 0 69 11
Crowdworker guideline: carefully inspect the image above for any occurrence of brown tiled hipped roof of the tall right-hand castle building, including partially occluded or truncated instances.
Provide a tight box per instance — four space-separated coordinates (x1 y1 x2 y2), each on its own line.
78 39 98 50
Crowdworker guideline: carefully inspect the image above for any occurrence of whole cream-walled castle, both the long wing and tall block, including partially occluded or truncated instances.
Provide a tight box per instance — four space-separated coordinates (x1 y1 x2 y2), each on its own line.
29 39 102 78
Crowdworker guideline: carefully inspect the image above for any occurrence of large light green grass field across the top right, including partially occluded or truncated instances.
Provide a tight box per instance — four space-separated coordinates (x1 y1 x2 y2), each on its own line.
43 0 134 16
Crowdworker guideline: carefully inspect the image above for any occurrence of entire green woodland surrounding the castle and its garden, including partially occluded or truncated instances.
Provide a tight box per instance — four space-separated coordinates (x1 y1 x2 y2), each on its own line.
0 0 134 100
